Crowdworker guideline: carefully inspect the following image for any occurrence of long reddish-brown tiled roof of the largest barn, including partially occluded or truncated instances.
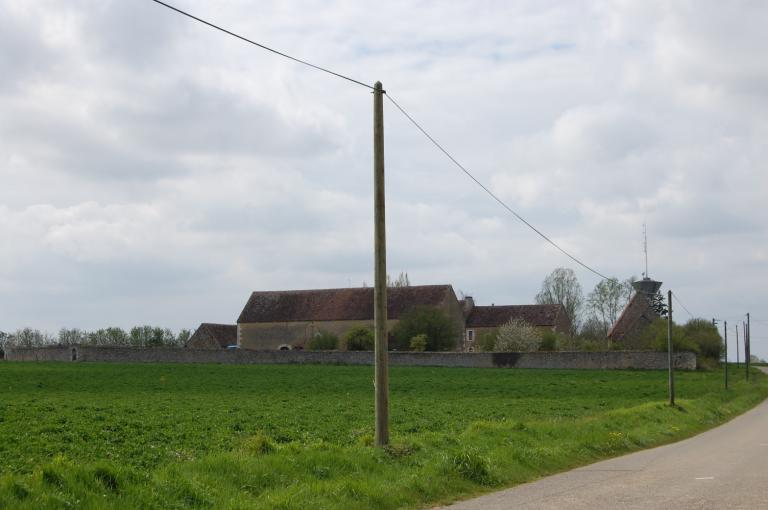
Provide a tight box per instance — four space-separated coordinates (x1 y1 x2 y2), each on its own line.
237 285 456 324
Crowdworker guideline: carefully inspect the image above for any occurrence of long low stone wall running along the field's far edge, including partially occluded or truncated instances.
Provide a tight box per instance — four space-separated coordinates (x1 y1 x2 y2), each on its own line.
5 347 696 370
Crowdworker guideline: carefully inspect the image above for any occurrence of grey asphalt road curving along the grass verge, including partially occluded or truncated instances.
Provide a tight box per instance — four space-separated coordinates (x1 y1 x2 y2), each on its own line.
438 369 768 510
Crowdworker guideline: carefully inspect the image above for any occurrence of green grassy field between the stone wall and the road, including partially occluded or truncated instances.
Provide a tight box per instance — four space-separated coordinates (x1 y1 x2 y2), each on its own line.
0 363 768 509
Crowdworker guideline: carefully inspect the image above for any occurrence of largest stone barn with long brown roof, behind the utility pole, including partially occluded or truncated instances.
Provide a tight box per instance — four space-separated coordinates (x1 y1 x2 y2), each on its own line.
237 285 464 349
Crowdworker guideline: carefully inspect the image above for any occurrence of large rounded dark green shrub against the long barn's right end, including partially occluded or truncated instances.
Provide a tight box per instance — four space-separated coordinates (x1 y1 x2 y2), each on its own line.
392 306 460 351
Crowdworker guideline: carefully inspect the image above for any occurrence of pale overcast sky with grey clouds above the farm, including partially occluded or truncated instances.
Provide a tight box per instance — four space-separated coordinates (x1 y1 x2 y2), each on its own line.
0 0 768 357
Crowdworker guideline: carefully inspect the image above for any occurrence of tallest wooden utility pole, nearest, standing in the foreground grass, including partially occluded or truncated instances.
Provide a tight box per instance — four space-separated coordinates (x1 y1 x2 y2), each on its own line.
373 81 389 446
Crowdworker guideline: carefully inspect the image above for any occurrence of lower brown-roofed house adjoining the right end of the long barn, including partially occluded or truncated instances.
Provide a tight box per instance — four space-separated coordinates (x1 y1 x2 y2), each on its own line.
464 297 571 351
